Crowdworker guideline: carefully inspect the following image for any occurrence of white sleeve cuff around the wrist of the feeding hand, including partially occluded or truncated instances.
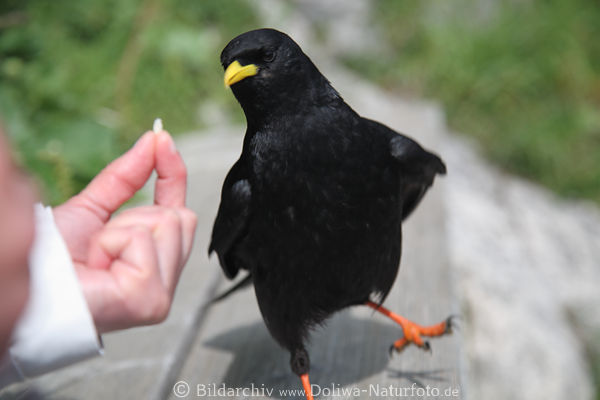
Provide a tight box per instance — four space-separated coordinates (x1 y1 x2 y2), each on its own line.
0 204 102 388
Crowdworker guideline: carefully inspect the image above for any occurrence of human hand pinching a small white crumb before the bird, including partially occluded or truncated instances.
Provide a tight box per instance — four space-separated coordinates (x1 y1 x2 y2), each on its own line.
54 131 196 333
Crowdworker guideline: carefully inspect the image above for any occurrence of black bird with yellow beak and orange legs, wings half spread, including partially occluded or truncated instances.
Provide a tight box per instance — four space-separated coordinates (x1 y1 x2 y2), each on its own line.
209 29 451 399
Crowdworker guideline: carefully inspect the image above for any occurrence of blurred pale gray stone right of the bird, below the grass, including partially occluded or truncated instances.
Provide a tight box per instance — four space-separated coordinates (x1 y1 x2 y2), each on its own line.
443 137 600 399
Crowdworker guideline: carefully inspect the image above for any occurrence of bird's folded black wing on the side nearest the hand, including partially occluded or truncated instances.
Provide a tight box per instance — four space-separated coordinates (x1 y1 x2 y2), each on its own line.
208 160 252 279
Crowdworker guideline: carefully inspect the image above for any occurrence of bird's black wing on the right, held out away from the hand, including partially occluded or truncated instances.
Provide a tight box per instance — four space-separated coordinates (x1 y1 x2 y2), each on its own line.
390 134 446 219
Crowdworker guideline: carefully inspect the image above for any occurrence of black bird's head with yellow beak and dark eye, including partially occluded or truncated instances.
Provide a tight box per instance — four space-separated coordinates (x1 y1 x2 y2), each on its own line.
221 29 339 122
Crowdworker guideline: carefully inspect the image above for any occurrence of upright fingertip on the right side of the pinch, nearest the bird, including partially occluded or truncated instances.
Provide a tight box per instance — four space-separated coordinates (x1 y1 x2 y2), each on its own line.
154 131 187 207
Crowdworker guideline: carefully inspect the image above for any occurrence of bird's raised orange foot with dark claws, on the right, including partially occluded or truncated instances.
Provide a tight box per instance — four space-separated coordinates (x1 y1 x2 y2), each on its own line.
366 301 454 354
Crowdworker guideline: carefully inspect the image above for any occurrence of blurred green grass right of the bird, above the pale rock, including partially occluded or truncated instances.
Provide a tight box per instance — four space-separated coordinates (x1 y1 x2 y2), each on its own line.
345 0 600 202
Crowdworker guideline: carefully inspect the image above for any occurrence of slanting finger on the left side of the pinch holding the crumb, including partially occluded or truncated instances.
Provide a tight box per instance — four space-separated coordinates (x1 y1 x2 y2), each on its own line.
72 132 155 221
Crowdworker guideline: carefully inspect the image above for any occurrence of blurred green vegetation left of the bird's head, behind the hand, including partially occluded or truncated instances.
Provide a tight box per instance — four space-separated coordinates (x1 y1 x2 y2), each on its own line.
0 0 255 204
